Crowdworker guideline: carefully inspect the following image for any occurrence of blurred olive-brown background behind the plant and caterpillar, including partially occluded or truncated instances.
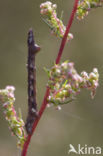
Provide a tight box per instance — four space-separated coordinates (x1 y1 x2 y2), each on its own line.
0 0 103 156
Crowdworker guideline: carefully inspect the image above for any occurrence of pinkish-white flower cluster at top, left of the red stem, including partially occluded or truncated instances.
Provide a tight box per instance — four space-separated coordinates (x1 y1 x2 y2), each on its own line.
40 1 73 40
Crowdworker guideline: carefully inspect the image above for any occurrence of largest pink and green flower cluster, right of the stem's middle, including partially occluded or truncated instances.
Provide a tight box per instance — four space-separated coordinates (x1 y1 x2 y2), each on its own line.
46 61 99 108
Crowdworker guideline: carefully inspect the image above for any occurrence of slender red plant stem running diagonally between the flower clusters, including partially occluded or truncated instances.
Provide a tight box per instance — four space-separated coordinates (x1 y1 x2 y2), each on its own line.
21 0 79 156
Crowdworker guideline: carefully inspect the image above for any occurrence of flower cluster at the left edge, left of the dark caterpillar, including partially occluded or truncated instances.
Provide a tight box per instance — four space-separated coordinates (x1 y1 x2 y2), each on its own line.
0 86 26 148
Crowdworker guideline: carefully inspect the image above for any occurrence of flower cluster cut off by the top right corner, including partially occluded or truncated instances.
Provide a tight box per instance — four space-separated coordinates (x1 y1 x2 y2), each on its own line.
77 0 103 20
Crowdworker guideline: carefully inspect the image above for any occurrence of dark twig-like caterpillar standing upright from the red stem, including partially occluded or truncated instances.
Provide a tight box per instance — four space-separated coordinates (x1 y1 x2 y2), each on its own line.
25 29 40 134
